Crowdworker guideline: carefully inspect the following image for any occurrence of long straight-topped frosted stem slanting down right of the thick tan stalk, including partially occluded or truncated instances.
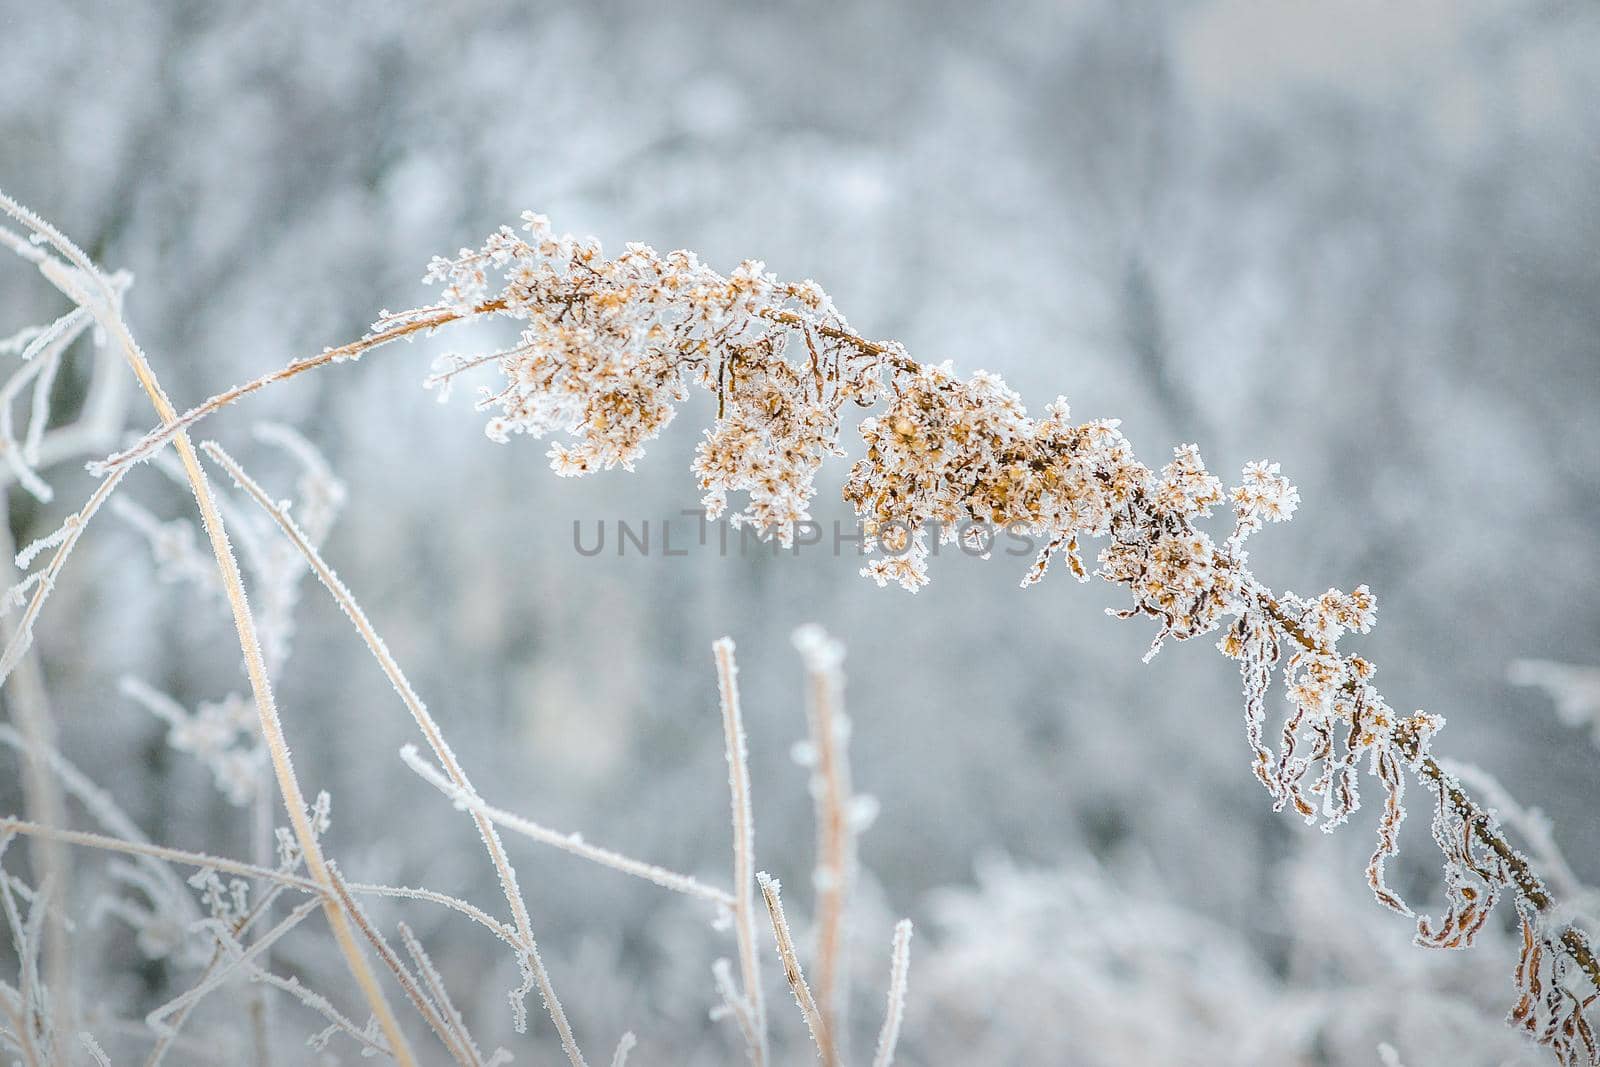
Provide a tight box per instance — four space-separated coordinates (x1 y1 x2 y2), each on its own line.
202 442 587 1067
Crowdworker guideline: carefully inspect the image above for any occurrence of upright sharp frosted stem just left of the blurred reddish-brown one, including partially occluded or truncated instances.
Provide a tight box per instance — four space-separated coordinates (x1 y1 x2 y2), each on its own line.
712 637 768 1067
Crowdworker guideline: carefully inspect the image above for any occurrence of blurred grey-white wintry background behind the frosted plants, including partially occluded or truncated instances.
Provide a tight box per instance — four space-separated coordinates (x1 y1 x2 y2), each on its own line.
0 0 1600 1065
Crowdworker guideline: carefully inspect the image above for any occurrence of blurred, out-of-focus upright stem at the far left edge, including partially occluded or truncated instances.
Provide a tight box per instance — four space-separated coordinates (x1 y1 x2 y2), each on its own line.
0 488 74 1033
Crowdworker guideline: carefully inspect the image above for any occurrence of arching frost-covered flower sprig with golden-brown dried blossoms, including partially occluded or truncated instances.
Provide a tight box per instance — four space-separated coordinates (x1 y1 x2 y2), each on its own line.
395 214 1600 1064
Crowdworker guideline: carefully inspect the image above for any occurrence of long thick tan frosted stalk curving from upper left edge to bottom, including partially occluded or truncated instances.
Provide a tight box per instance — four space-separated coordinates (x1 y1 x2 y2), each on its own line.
0 225 416 1067
